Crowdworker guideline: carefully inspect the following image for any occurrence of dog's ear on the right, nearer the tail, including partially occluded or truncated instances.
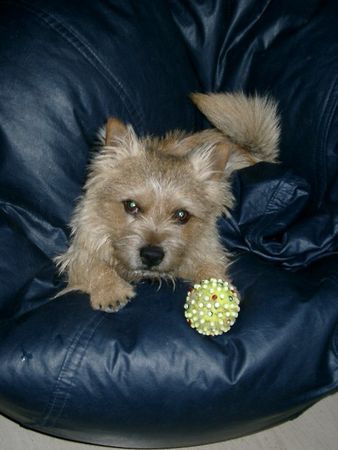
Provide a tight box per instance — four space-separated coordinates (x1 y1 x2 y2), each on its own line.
187 142 230 181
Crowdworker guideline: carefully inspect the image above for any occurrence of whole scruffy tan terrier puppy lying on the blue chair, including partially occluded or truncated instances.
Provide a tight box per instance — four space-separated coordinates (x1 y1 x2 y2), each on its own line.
57 93 279 312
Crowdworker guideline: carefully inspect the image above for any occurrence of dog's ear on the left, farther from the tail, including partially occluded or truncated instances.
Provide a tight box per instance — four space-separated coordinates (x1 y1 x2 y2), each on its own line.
104 117 143 159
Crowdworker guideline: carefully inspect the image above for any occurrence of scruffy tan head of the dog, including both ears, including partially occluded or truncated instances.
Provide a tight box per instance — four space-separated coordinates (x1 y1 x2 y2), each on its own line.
86 119 232 279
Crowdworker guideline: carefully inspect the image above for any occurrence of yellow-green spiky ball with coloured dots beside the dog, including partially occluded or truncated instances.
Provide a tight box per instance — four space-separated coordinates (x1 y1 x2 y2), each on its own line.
184 278 240 336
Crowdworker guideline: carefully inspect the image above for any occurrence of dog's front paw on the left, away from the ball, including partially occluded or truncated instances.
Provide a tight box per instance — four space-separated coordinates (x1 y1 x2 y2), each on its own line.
90 280 136 313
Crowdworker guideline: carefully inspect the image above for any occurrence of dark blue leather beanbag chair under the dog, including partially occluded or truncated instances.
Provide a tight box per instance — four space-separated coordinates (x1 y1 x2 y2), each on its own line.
0 0 338 448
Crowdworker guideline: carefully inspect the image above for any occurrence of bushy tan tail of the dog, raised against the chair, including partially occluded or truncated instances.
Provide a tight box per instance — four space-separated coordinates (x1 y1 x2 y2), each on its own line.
191 92 280 162
